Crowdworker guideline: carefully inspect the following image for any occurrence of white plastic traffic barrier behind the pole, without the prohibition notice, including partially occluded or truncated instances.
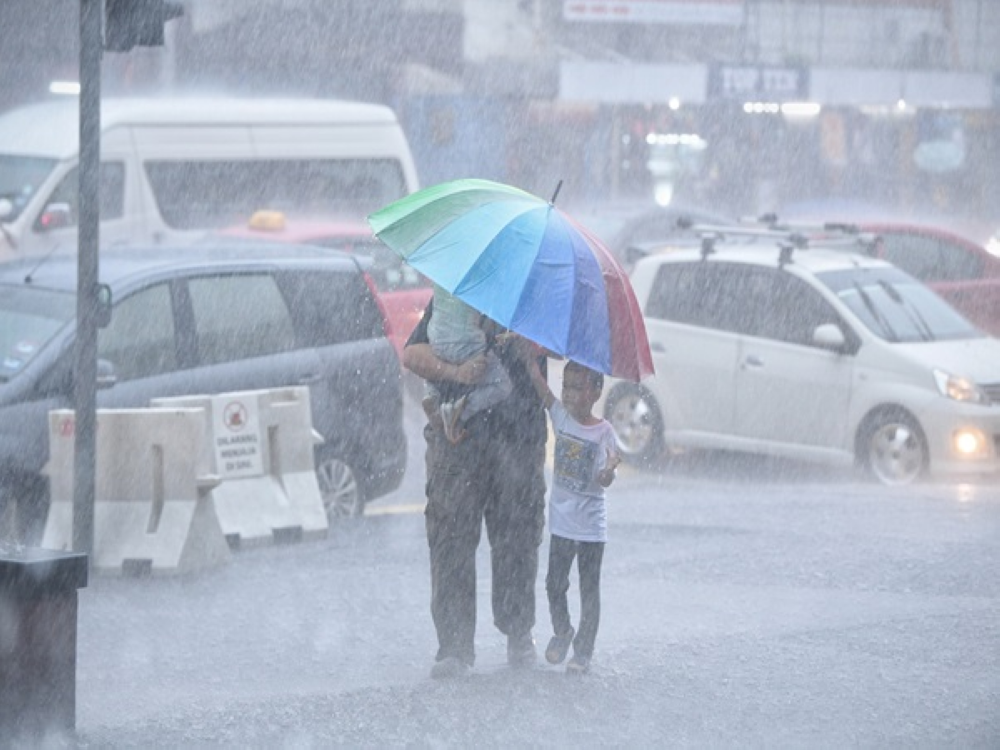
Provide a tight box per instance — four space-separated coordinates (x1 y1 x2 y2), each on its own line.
42 408 231 576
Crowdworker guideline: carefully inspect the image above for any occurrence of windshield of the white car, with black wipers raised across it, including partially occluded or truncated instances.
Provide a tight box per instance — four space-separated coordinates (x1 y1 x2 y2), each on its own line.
816 268 985 342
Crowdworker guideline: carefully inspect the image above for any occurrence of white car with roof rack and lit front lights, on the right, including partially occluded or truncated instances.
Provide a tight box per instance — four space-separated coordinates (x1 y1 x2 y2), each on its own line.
604 239 1000 484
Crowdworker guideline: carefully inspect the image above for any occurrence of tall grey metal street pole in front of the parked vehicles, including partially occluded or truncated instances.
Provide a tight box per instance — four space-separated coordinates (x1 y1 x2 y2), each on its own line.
73 0 104 560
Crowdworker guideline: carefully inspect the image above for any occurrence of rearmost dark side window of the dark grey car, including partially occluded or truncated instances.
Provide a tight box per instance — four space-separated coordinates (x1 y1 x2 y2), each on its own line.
278 272 384 347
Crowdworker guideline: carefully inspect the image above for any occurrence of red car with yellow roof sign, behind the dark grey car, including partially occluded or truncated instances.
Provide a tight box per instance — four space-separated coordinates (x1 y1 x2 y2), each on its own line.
220 211 433 359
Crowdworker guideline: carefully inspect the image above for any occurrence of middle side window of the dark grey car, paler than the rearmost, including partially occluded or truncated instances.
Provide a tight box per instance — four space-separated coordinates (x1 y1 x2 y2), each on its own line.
188 274 295 365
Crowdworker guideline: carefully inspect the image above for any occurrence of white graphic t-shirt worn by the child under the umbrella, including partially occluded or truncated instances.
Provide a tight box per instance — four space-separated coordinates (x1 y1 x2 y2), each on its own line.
549 400 618 542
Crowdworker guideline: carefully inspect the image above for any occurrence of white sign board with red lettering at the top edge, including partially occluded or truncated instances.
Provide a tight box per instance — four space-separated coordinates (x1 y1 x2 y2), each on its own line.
563 0 744 26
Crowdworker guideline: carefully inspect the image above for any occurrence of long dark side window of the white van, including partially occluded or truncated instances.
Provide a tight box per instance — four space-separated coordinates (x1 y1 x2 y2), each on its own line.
145 159 406 229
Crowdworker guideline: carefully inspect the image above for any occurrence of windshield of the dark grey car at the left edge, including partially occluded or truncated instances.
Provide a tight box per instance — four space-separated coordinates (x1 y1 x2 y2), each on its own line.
0 286 76 382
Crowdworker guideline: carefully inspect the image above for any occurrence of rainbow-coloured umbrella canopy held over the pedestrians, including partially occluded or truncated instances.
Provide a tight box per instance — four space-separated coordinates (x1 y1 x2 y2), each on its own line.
368 180 653 381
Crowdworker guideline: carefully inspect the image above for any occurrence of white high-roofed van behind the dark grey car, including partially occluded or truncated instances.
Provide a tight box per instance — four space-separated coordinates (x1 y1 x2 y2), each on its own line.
0 98 418 261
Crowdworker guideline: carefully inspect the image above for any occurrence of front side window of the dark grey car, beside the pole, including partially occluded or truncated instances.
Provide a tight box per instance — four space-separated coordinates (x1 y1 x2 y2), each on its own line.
97 284 177 380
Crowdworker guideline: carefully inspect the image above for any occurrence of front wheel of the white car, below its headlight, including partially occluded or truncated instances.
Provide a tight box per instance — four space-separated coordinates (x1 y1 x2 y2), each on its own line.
860 411 927 485
